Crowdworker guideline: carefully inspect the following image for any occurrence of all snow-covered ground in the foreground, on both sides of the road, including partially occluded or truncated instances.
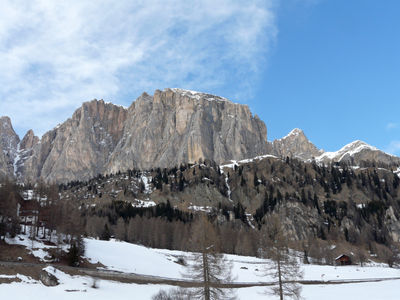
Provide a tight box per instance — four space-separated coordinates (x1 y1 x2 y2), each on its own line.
0 239 400 300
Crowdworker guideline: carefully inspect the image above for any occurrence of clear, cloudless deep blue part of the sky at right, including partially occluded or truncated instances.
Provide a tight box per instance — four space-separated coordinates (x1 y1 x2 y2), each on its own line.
252 0 400 154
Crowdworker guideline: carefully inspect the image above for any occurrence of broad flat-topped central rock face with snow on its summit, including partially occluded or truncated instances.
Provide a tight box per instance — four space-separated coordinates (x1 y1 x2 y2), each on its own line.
107 89 267 173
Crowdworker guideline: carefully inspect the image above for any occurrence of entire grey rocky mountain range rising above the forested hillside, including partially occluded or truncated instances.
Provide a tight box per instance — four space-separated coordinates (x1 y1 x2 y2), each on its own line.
0 89 400 183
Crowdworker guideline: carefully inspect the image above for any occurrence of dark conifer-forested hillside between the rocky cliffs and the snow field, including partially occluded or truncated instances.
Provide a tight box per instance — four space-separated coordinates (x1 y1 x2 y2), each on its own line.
10 156 388 264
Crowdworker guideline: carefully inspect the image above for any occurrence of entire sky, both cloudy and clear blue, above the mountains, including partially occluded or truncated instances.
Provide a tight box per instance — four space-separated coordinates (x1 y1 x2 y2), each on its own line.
0 0 400 155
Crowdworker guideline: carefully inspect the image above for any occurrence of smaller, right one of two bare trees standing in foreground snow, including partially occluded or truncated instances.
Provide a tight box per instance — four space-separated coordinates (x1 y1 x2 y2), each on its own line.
261 215 303 300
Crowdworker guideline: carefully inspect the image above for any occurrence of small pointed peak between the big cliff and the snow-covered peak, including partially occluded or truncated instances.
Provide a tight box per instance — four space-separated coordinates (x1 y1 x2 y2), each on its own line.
270 128 323 161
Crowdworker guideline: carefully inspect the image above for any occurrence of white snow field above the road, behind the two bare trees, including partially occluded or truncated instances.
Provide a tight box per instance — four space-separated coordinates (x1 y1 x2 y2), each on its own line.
85 239 400 284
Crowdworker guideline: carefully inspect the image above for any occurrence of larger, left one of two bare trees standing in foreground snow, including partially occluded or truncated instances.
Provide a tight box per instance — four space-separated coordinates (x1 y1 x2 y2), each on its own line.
185 215 236 300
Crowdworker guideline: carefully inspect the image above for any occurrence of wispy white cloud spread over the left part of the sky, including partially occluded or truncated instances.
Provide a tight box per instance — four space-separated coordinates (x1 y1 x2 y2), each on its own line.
0 0 277 134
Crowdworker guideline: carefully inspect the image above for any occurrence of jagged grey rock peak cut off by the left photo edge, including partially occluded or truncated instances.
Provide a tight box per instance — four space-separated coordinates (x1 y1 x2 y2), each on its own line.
0 117 19 177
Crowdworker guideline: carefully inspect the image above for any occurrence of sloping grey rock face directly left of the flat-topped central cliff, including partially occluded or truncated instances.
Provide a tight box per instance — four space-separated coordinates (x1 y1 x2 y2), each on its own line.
22 100 127 182
